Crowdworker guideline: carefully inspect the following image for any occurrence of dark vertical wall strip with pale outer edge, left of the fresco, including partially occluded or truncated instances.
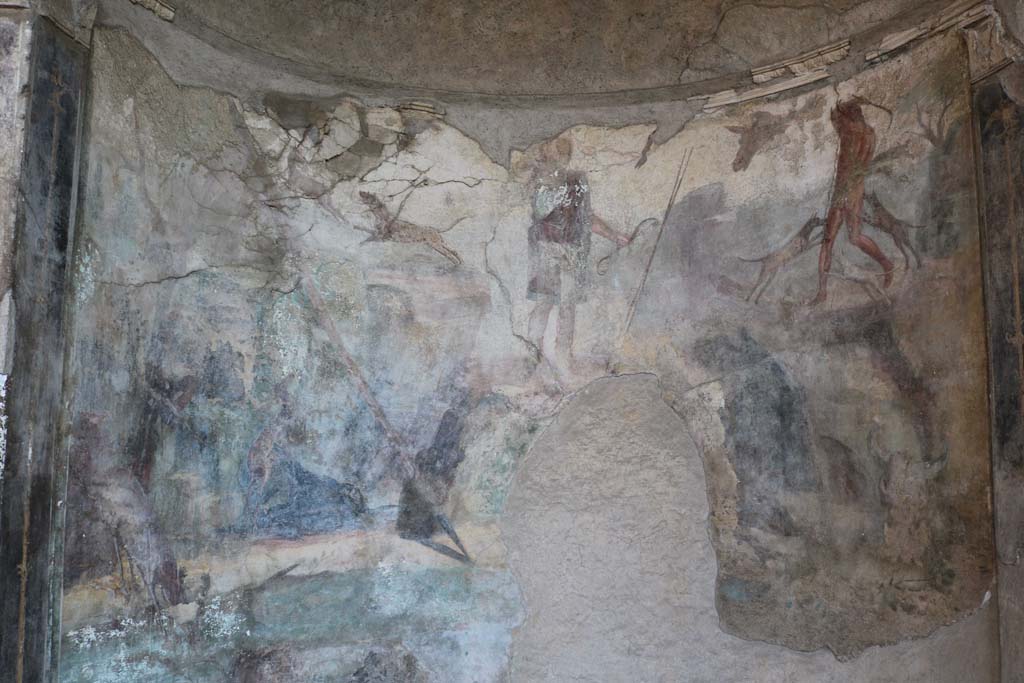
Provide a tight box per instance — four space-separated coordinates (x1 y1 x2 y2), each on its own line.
0 12 88 683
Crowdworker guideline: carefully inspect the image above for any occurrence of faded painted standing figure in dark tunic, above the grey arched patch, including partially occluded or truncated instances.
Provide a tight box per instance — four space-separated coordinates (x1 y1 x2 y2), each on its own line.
526 138 636 366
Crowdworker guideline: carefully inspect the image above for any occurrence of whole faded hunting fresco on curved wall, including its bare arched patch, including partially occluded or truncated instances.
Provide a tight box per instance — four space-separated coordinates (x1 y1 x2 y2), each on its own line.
60 25 993 683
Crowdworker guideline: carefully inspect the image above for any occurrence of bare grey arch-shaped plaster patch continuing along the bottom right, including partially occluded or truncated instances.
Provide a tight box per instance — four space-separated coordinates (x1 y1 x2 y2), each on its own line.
502 375 997 683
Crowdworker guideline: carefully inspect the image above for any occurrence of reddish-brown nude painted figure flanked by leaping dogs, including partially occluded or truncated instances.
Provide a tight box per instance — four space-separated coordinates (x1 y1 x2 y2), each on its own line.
811 100 893 305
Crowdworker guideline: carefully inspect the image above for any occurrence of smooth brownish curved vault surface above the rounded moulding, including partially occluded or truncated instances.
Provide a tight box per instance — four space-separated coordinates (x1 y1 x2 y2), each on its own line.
144 0 949 94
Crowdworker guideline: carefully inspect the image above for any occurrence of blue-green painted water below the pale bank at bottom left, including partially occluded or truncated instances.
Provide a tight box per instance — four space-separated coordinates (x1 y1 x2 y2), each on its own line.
60 565 521 683
